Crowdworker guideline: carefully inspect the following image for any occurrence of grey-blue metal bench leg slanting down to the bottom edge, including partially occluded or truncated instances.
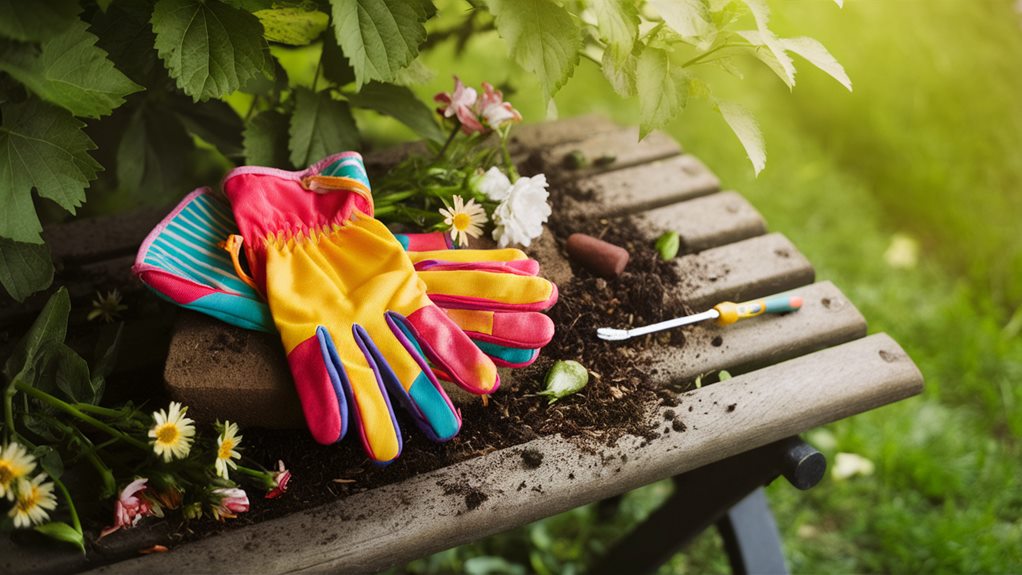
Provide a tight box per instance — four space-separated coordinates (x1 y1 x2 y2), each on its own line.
716 487 788 575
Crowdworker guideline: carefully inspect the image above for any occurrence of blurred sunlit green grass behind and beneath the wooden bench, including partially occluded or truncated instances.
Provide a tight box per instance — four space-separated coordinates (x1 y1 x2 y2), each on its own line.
398 0 1022 573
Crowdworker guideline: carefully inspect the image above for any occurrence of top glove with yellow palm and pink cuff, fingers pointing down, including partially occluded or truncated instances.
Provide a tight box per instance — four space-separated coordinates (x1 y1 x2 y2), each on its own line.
224 153 552 462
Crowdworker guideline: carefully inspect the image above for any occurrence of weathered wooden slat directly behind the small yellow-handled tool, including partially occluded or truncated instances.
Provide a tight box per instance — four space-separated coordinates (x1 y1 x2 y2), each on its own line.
670 234 816 309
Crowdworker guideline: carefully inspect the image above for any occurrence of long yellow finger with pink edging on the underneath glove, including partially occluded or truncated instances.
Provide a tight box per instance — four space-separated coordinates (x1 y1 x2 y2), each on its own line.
418 271 557 312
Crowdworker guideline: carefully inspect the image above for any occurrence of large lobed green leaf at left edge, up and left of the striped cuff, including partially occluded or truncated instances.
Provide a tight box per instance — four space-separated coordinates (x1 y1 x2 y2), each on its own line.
0 98 102 243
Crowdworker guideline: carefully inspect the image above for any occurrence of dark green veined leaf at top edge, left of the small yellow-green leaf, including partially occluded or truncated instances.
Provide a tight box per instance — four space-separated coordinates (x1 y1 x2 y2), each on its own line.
152 0 272 101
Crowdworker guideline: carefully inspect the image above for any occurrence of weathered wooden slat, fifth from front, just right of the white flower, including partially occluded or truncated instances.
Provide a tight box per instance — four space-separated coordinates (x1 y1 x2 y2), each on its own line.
561 155 721 219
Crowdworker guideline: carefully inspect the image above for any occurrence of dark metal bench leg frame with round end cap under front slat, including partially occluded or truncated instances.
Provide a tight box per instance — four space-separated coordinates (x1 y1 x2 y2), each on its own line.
593 437 827 574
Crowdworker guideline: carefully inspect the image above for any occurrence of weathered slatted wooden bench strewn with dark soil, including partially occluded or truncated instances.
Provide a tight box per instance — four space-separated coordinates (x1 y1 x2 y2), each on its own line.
0 117 922 573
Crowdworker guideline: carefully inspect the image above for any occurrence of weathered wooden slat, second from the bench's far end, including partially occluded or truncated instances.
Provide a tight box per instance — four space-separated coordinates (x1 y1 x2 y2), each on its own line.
539 128 682 178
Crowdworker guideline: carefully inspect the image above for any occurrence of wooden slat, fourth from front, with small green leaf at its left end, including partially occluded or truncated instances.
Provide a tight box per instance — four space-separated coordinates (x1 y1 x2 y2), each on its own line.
635 190 767 253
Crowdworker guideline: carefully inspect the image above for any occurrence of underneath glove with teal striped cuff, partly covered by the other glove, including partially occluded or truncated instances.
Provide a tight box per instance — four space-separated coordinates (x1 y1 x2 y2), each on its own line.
133 188 557 369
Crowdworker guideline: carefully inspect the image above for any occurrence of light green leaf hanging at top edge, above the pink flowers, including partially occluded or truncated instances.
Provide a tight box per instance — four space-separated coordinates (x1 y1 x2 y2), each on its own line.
487 0 582 98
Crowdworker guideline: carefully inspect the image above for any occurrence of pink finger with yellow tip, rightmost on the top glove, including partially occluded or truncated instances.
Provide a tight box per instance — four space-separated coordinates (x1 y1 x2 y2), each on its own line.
386 305 501 394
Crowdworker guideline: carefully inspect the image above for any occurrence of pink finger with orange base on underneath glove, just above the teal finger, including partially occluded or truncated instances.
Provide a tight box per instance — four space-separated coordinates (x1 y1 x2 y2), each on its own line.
444 309 554 349
